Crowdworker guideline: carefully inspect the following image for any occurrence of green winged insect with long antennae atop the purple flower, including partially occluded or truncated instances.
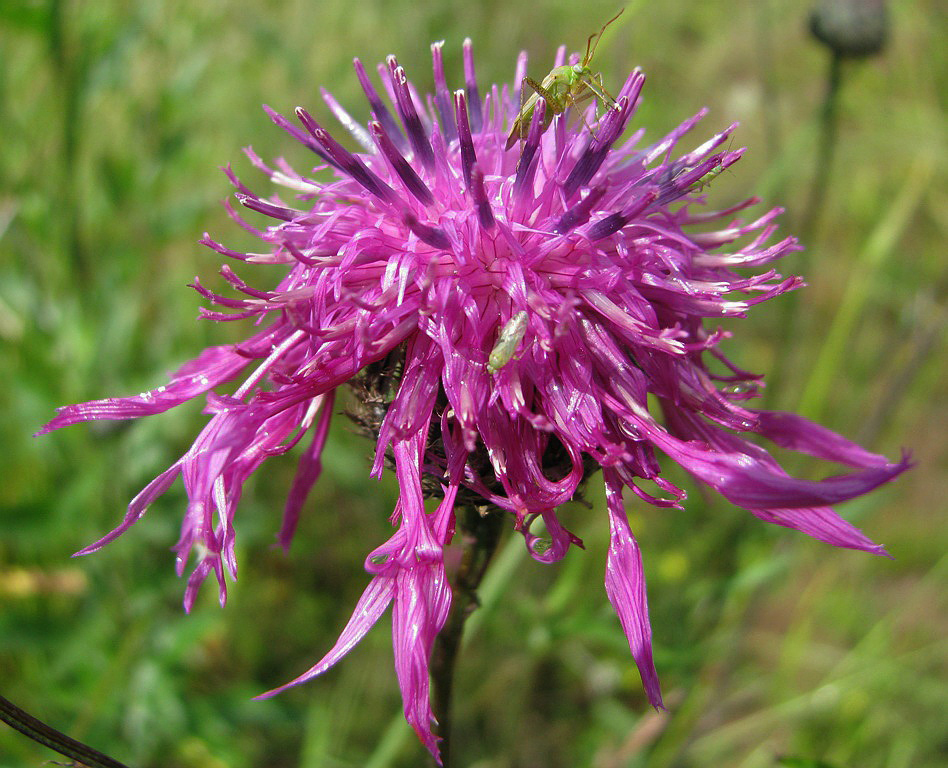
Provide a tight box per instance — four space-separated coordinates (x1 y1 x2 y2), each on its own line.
504 8 625 149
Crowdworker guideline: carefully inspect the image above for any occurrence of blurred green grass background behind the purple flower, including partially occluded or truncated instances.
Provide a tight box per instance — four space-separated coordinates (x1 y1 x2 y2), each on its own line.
0 0 948 768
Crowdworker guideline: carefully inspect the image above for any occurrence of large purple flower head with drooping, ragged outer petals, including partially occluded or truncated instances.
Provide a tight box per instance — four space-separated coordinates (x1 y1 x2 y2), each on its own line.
42 42 908 756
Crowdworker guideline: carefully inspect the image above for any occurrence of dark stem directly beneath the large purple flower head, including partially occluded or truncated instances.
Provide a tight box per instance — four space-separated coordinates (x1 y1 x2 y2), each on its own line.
431 508 503 768
